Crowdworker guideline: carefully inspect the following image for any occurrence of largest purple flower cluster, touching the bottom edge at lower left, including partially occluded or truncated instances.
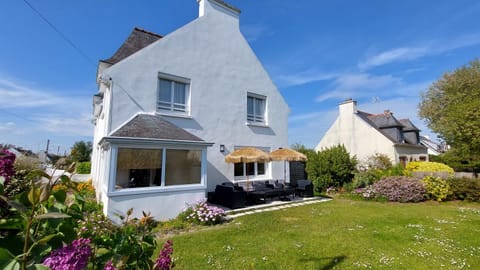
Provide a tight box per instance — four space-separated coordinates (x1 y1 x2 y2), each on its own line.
43 238 92 270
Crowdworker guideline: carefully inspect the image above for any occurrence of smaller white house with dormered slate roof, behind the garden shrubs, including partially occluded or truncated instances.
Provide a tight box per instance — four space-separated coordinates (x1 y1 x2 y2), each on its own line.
315 99 428 164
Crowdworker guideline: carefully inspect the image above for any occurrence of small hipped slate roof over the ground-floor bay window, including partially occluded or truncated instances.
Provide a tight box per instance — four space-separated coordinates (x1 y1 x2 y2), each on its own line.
112 114 203 142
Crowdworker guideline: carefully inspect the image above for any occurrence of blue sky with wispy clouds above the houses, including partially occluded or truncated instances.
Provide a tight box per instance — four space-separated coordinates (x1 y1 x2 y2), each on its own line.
0 0 480 153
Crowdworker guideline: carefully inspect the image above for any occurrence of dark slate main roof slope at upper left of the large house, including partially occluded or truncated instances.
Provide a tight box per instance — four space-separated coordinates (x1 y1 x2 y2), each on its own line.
101 27 162 65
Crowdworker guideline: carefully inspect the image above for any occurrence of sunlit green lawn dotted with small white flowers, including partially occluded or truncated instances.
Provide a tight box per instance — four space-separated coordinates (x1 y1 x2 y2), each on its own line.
162 198 480 269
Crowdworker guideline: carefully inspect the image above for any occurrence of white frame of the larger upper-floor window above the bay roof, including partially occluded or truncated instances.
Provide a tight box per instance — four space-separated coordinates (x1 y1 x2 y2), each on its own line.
156 72 191 116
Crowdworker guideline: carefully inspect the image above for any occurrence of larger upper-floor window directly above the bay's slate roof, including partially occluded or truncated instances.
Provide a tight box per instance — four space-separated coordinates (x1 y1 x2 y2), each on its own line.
157 73 190 114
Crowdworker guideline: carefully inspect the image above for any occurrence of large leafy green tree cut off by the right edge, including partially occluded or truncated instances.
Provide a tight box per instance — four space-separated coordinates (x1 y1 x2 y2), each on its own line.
418 59 480 161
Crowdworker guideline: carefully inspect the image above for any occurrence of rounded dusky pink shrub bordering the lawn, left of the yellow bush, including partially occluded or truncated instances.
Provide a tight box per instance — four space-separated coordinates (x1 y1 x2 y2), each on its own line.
373 176 425 202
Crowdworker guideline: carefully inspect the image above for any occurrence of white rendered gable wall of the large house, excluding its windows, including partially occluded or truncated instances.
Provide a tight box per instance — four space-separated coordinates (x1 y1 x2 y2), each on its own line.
99 2 289 194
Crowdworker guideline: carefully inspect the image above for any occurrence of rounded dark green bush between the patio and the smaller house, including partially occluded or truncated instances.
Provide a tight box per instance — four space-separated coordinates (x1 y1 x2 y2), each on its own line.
306 145 357 191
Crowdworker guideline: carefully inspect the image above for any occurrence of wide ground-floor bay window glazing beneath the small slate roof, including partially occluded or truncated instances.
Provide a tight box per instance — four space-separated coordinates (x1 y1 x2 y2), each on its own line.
115 148 202 189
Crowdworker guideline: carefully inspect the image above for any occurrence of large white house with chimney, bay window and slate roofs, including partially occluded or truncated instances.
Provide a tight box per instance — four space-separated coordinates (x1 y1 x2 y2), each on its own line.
92 0 289 219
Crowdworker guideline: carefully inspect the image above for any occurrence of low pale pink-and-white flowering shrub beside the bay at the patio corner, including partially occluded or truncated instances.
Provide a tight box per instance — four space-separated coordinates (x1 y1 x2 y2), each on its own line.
181 200 225 225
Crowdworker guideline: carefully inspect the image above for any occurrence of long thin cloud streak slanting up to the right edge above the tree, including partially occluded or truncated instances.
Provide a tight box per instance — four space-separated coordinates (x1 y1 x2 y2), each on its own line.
358 33 480 70
